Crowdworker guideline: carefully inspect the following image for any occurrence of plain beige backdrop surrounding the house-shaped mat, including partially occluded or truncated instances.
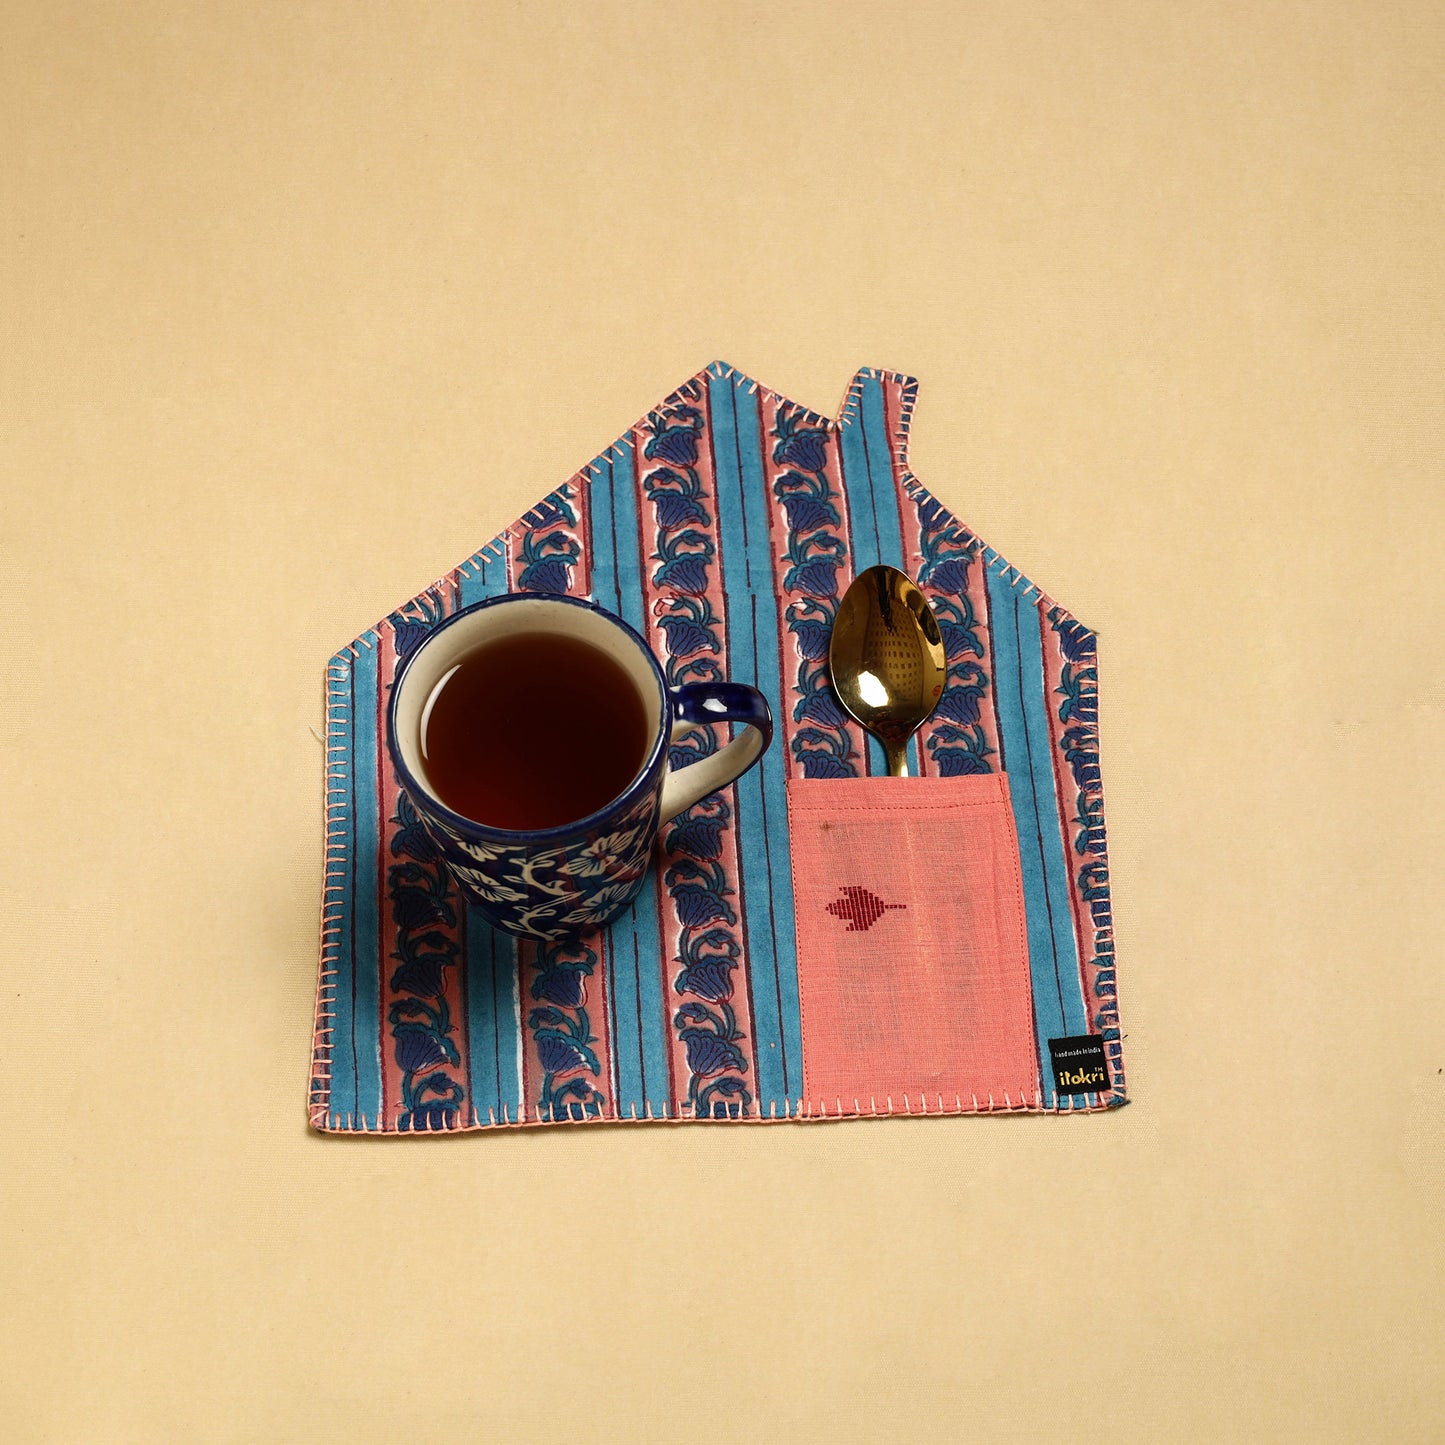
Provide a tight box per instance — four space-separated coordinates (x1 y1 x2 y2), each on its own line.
0 0 1445 1445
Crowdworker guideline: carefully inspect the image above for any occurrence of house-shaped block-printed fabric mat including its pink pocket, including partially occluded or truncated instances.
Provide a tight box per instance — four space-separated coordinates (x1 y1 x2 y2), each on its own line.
309 363 1126 1134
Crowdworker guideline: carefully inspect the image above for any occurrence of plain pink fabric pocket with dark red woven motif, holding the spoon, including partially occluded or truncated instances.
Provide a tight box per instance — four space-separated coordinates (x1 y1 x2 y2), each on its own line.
788 773 1039 1114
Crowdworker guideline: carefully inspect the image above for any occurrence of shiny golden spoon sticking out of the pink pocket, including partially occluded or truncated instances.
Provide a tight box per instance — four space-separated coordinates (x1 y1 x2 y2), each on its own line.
828 566 948 777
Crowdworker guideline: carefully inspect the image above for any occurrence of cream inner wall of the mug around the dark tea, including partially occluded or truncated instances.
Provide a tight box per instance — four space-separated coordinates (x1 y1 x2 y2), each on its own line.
396 597 663 814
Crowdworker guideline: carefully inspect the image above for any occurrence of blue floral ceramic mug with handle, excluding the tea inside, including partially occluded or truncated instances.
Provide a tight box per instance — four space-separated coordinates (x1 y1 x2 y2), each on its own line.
386 592 773 941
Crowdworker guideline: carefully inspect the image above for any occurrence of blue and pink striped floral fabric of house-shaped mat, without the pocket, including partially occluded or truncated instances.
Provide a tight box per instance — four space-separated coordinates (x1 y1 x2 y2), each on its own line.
311 363 1124 1133
